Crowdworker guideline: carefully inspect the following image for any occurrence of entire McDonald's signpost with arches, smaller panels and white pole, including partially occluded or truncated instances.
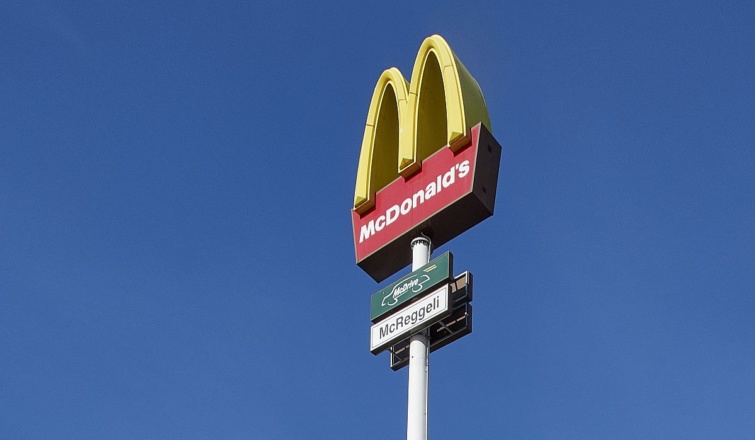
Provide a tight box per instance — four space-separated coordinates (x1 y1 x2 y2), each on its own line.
351 35 501 440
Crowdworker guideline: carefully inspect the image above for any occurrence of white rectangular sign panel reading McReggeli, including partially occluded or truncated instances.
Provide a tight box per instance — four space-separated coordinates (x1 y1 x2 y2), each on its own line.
370 284 451 354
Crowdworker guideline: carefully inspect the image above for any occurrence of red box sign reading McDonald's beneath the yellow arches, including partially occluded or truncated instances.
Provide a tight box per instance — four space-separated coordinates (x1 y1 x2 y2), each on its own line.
351 124 501 282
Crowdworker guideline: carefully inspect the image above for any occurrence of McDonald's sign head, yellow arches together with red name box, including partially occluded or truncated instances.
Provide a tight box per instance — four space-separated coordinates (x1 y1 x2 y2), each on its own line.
351 35 501 281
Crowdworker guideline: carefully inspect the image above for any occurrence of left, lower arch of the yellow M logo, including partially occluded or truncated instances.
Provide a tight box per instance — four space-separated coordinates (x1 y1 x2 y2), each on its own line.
354 67 409 214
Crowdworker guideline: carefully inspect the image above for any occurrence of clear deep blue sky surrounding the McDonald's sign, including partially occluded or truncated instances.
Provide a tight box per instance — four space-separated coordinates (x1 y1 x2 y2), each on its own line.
0 0 755 440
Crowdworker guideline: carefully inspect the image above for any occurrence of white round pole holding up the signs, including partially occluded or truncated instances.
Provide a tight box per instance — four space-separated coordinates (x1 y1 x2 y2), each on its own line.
406 237 432 440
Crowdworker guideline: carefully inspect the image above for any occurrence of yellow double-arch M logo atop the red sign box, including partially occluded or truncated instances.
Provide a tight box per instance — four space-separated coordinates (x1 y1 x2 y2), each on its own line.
354 35 490 214
